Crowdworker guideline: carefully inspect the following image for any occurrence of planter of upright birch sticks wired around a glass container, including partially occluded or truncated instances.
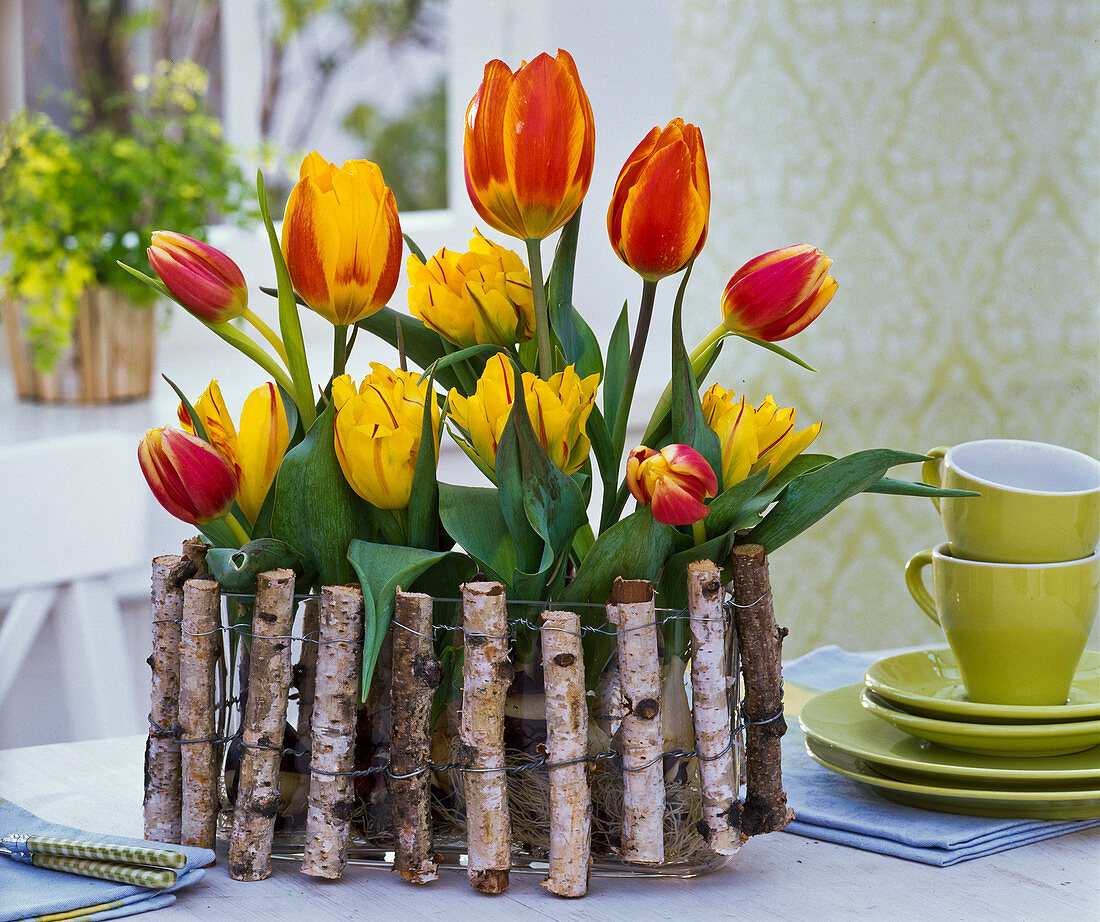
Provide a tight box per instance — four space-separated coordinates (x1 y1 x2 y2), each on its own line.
145 546 792 897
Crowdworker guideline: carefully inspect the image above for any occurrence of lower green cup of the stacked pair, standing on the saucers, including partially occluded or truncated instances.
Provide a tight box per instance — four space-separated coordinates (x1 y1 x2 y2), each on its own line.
905 544 1100 705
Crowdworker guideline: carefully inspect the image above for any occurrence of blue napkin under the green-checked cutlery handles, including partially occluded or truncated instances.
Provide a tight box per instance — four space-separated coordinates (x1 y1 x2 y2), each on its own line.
0 799 215 922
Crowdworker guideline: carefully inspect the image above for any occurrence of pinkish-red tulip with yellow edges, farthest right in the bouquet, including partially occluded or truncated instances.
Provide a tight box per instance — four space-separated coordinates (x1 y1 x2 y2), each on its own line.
722 243 837 342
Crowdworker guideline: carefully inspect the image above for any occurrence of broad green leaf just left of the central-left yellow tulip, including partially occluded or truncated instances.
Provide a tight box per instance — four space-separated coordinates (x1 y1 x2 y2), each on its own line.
272 404 370 585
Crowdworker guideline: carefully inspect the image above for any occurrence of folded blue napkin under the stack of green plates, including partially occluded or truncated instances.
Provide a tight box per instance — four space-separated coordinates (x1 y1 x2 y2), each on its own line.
783 646 1100 867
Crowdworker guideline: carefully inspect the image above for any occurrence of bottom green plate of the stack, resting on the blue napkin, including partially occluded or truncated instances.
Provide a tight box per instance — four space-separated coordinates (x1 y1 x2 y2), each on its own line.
806 734 1100 820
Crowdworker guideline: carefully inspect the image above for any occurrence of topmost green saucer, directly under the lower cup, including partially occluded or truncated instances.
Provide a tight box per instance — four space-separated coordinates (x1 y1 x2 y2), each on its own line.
864 650 1100 724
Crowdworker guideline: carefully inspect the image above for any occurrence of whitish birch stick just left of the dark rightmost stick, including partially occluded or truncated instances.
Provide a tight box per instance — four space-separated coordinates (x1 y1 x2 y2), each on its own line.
688 560 741 855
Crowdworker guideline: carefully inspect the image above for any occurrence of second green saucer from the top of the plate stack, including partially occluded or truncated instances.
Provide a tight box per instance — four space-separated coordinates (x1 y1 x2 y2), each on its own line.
855 685 1100 757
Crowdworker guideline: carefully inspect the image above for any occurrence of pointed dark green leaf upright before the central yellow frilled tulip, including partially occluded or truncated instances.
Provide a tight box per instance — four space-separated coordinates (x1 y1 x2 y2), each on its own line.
496 365 586 573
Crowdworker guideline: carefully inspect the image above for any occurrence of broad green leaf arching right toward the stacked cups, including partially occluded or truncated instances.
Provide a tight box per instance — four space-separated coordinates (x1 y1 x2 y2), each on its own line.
747 448 925 553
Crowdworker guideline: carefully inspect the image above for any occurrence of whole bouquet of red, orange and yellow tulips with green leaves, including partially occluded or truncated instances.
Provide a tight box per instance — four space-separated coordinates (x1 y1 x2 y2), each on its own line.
128 51 954 721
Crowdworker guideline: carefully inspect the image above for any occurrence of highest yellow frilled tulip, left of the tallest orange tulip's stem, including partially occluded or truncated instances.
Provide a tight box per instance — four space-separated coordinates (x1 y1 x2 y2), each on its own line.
406 230 535 348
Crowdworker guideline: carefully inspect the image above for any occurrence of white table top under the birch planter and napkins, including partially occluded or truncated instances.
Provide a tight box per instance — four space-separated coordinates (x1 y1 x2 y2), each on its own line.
0 736 1100 922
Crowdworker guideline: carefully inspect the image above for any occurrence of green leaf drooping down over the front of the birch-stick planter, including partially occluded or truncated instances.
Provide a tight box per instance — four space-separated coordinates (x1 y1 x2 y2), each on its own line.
348 540 453 702
